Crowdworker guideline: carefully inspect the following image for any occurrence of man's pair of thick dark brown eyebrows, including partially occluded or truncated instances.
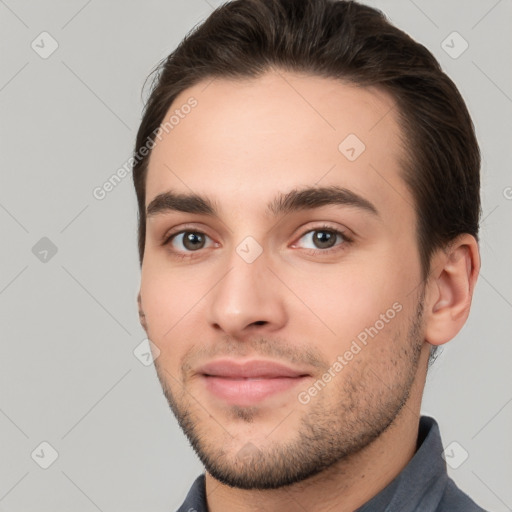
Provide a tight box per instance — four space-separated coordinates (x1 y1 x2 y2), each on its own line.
146 185 379 218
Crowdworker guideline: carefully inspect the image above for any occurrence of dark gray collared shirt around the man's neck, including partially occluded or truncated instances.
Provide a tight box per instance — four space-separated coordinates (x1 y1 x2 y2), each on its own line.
177 416 486 512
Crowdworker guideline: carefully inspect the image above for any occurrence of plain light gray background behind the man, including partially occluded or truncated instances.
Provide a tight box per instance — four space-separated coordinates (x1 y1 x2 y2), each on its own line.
0 0 512 512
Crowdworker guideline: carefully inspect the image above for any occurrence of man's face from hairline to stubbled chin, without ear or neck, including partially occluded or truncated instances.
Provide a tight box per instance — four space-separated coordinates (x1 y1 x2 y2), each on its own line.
140 72 426 489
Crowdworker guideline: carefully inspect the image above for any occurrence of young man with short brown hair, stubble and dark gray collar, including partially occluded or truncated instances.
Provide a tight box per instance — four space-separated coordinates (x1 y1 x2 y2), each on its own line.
134 0 488 512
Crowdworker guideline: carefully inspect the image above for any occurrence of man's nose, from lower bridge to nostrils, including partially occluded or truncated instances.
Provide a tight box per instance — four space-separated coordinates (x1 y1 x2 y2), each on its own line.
208 251 287 339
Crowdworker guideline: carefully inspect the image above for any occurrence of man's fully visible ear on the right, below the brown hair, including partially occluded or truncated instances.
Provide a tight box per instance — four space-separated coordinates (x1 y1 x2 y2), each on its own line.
425 234 480 345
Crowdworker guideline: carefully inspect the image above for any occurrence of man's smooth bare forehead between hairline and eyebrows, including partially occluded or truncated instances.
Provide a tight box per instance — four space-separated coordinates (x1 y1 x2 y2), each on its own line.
146 71 412 224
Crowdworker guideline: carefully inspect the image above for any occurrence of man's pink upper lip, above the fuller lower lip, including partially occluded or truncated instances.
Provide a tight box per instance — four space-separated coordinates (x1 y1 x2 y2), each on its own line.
197 359 309 380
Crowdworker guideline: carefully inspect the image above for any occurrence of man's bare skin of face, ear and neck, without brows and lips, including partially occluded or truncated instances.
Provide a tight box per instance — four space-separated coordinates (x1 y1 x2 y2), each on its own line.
138 70 480 512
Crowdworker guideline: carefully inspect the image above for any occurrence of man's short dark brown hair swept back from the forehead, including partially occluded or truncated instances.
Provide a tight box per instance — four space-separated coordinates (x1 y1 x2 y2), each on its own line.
133 0 481 352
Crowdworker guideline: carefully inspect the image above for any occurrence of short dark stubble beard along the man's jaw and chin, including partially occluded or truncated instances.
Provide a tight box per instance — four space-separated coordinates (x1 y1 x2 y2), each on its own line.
155 294 424 490
